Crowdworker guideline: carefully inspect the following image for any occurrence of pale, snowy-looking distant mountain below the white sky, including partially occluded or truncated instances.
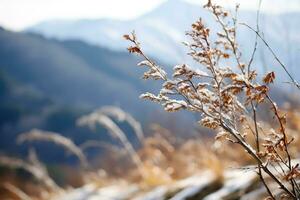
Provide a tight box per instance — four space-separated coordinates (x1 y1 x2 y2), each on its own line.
25 0 300 83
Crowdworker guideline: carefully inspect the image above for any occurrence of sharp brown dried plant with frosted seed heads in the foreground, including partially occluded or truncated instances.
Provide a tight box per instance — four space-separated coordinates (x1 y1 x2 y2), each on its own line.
124 0 300 199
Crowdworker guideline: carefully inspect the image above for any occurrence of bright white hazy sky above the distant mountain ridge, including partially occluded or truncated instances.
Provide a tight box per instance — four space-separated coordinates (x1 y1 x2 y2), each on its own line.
0 0 300 30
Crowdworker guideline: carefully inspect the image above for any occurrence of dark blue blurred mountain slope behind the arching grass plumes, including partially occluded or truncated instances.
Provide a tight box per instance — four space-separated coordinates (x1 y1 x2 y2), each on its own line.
0 29 165 161
